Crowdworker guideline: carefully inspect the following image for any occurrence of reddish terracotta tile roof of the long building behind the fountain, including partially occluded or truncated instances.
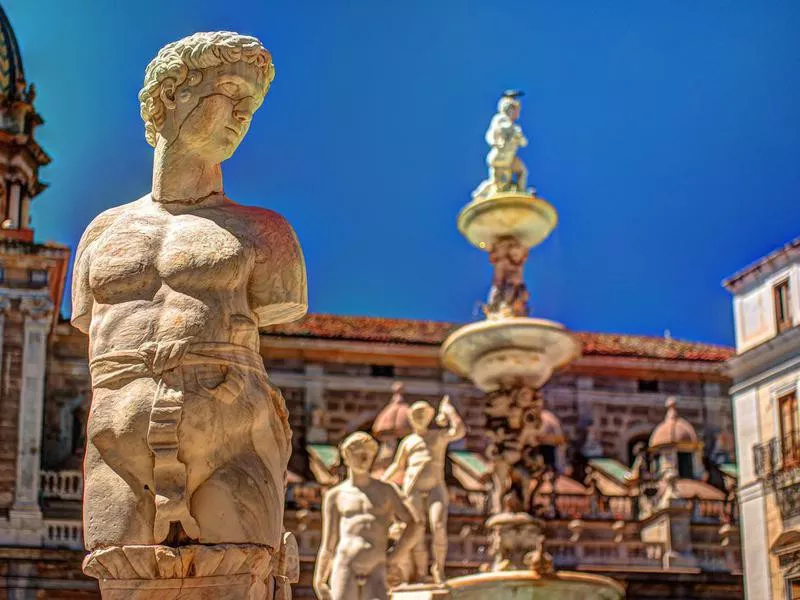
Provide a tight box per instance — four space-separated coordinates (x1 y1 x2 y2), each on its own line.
265 313 734 362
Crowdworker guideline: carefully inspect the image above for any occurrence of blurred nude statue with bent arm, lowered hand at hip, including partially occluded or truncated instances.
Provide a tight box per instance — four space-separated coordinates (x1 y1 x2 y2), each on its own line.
314 431 424 600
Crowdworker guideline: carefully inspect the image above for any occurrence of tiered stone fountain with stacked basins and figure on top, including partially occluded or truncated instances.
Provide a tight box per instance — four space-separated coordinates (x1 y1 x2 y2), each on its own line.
434 92 624 600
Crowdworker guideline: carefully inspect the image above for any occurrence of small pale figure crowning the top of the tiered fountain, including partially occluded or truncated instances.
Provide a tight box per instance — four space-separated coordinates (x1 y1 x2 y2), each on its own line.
472 90 528 199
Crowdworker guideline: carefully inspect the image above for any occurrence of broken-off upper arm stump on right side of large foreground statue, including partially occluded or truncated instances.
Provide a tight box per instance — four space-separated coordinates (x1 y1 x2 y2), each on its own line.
248 210 308 327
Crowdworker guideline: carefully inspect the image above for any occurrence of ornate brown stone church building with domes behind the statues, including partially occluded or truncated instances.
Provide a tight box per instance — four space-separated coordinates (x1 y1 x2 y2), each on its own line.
0 8 743 599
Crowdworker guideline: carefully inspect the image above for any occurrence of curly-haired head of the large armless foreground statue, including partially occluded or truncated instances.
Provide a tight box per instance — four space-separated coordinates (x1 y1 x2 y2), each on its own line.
139 31 275 163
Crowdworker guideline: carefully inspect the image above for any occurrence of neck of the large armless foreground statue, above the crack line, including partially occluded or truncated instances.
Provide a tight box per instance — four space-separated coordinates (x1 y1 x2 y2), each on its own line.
152 138 222 204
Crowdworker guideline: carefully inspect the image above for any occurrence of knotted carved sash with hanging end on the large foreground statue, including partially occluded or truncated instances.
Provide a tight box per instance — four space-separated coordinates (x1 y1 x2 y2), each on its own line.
89 340 265 543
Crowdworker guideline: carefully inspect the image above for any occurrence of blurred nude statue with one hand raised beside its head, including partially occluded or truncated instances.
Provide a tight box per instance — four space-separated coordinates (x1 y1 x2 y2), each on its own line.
382 396 466 583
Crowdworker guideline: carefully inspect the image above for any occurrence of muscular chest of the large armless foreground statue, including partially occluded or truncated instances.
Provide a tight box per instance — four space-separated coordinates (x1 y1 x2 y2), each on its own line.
89 209 251 301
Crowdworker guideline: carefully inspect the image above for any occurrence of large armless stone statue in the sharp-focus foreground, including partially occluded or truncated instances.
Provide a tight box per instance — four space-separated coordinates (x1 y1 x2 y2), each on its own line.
72 32 307 598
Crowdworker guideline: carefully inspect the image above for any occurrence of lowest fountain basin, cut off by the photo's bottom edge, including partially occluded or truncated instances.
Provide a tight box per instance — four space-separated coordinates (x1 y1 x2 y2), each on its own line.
447 571 625 600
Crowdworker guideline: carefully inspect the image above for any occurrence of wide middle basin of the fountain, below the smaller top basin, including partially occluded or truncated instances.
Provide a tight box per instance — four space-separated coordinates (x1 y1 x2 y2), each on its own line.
440 317 580 392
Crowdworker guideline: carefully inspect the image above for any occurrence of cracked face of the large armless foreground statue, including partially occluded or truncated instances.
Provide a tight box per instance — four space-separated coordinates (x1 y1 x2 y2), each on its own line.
164 61 263 163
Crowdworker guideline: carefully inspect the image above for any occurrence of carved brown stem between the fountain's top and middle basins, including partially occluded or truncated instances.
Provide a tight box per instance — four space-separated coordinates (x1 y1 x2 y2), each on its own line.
483 237 530 319
